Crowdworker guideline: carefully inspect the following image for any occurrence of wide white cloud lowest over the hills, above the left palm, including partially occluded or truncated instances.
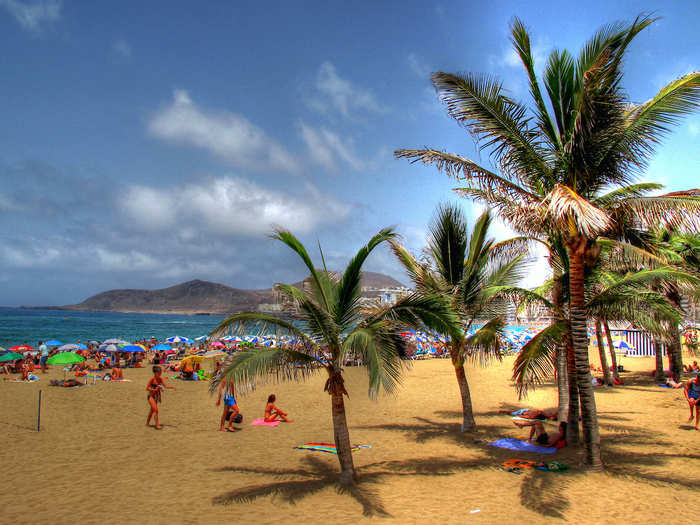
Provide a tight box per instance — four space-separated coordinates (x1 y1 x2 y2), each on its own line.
119 177 350 237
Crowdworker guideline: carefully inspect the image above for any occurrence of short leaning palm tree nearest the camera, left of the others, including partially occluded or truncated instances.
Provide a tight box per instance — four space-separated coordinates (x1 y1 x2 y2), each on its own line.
211 229 459 485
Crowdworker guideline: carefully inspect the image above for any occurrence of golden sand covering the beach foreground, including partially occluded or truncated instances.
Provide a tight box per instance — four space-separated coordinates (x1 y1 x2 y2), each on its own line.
0 352 700 524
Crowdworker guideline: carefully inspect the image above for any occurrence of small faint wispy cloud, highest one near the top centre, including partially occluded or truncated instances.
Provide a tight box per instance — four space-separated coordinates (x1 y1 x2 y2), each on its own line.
307 62 387 117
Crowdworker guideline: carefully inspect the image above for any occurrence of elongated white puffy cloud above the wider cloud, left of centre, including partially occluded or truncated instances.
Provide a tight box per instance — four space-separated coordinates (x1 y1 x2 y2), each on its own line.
148 90 299 173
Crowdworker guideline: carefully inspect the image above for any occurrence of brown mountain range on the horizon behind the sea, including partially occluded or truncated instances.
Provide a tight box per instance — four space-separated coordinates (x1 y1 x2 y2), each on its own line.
48 272 403 314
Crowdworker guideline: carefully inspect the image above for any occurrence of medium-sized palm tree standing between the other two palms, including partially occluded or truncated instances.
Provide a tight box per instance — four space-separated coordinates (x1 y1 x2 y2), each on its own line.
391 204 523 432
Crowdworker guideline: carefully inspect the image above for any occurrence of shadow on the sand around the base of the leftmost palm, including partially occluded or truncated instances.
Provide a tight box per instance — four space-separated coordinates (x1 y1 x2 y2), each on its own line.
212 457 490 517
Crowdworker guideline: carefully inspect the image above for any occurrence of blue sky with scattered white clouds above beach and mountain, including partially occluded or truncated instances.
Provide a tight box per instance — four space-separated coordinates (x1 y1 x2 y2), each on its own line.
0 0 700 306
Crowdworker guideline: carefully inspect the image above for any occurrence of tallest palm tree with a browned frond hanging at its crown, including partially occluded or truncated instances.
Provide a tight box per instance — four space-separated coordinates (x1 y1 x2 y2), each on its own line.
396 17 700 468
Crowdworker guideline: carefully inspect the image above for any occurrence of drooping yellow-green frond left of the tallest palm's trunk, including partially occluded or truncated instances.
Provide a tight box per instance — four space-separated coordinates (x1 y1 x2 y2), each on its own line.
513 321 568 399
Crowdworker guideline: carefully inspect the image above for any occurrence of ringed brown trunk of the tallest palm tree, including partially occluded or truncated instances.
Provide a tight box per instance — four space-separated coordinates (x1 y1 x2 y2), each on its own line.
569 244 603 470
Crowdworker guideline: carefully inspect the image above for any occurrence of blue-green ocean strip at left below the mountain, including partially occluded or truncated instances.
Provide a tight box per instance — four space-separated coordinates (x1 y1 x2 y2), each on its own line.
0 308 225 348
